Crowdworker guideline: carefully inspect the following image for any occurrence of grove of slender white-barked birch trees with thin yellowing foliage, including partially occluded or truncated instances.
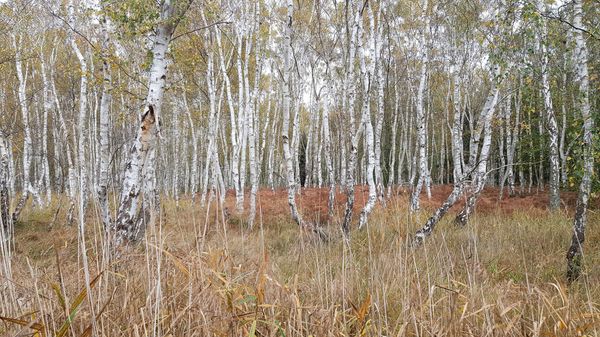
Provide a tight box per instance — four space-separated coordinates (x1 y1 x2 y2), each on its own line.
0 0 600 280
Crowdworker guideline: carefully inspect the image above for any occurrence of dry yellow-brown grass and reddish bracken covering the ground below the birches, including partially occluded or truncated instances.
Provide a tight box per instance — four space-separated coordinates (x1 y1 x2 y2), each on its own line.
0 186 600 337
